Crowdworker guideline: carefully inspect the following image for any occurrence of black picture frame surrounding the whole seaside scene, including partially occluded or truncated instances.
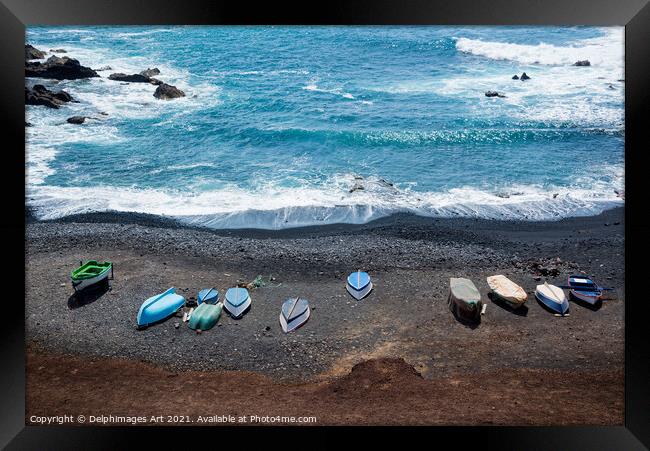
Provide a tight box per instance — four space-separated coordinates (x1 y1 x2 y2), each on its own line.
0 0 650 450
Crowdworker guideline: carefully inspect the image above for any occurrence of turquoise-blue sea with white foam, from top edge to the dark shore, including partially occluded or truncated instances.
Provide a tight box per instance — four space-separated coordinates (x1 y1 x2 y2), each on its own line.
26 26 625 229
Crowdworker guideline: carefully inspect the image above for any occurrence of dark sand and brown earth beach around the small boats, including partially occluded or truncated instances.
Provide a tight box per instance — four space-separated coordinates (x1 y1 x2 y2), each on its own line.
26 208 625 424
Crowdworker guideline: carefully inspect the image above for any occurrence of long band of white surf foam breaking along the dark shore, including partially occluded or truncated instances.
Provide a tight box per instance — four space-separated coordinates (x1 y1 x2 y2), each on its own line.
29 172 623 229
